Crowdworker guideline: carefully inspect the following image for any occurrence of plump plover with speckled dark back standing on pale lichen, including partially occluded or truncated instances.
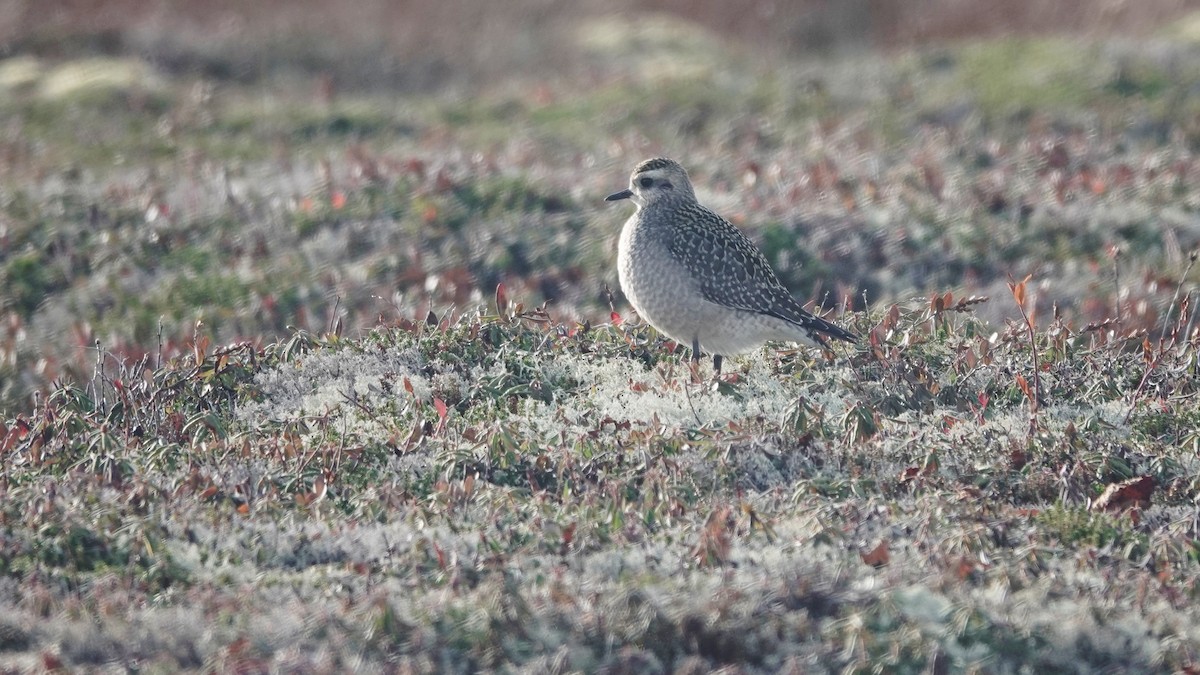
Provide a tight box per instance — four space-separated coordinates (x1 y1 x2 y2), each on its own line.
605 157 858 376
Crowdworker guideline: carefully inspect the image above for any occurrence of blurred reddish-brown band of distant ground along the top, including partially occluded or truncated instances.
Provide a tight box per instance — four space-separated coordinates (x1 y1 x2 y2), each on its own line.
0 0 1198 89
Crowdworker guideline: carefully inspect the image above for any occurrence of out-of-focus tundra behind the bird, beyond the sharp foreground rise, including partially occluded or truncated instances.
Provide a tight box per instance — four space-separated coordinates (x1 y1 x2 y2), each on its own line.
0 0 1200 413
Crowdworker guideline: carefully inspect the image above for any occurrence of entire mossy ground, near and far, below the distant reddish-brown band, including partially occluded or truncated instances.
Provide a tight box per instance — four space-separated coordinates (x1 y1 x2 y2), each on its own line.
0 13 1200 673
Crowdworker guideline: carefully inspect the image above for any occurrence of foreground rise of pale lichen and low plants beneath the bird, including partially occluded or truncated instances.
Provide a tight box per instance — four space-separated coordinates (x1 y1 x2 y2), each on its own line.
0 296 1200 673
